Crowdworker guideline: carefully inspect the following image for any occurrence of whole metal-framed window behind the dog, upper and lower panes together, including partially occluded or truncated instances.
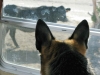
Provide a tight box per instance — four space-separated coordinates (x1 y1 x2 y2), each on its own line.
2 0 100 75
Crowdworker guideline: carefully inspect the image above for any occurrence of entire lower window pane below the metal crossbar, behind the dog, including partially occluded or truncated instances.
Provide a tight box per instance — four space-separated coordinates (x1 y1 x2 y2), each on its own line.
2 21 100 75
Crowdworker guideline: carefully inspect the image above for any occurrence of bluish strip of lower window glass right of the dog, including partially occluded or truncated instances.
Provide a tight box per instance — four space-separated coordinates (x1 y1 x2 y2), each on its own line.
87 33 100 75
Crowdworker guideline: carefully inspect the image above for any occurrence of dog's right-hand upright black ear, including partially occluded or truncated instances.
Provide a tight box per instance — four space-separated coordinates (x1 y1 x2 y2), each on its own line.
69 20 89 48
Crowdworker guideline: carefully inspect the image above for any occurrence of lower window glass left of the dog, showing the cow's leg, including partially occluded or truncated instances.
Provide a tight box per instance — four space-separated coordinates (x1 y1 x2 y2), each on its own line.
3 24 40 69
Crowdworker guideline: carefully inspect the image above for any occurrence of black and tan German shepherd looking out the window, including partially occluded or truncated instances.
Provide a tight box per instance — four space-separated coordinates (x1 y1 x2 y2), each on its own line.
35 19 94 75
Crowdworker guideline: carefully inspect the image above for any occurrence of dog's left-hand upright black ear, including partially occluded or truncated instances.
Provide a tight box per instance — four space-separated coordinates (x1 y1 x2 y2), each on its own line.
35 19 55 52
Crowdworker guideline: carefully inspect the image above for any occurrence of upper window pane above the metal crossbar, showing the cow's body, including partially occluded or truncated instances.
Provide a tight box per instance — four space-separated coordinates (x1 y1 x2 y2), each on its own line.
3 0 95 28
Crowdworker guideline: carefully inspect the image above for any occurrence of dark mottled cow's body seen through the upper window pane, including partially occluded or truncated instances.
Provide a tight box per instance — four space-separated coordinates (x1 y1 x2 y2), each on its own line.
4 5 71 22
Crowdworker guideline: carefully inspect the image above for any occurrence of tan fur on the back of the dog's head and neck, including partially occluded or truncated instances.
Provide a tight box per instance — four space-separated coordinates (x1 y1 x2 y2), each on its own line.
41 39 86 75
